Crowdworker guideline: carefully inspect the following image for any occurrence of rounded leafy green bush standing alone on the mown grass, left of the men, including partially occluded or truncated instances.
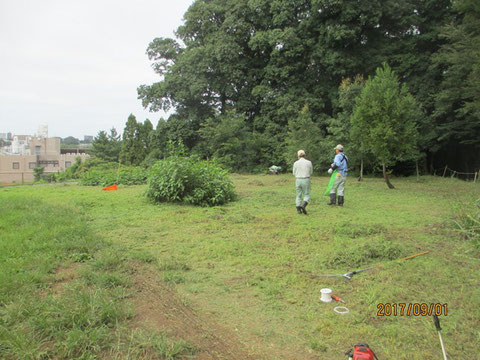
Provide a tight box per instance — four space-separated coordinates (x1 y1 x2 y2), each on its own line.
146 156 236 206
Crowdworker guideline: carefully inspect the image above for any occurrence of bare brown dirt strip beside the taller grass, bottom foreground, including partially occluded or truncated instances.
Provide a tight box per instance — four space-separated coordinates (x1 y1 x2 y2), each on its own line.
133 267 260 360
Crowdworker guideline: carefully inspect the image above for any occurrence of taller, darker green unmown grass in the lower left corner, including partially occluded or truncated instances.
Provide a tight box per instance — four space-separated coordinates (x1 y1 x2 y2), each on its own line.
0 188 192 359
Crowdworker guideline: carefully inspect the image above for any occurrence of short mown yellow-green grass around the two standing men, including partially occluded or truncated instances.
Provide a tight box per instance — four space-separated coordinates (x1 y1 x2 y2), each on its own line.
0 175 480 359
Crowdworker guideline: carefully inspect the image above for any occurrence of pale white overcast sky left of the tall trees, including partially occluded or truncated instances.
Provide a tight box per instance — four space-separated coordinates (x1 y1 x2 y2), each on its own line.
0 0 193 139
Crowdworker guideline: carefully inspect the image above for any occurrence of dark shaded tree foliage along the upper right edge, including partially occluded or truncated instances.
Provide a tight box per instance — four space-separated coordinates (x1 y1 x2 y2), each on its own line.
435 0 480 147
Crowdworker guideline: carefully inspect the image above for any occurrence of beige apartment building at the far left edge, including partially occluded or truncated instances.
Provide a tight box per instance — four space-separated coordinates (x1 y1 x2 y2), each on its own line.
0 135 88 184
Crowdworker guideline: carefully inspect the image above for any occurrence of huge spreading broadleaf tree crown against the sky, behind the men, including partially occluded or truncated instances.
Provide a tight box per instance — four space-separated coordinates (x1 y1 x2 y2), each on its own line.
138 0 458 173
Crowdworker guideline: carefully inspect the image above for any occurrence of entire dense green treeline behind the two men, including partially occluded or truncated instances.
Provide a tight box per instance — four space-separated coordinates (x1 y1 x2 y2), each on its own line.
94 0 480 174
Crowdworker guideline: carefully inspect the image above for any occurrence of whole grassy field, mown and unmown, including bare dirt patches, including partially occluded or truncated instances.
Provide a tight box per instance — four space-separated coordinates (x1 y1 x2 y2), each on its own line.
0 175 480 359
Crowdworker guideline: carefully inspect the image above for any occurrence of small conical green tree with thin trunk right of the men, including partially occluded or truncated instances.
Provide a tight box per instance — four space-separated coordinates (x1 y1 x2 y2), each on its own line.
352 64 421 189
